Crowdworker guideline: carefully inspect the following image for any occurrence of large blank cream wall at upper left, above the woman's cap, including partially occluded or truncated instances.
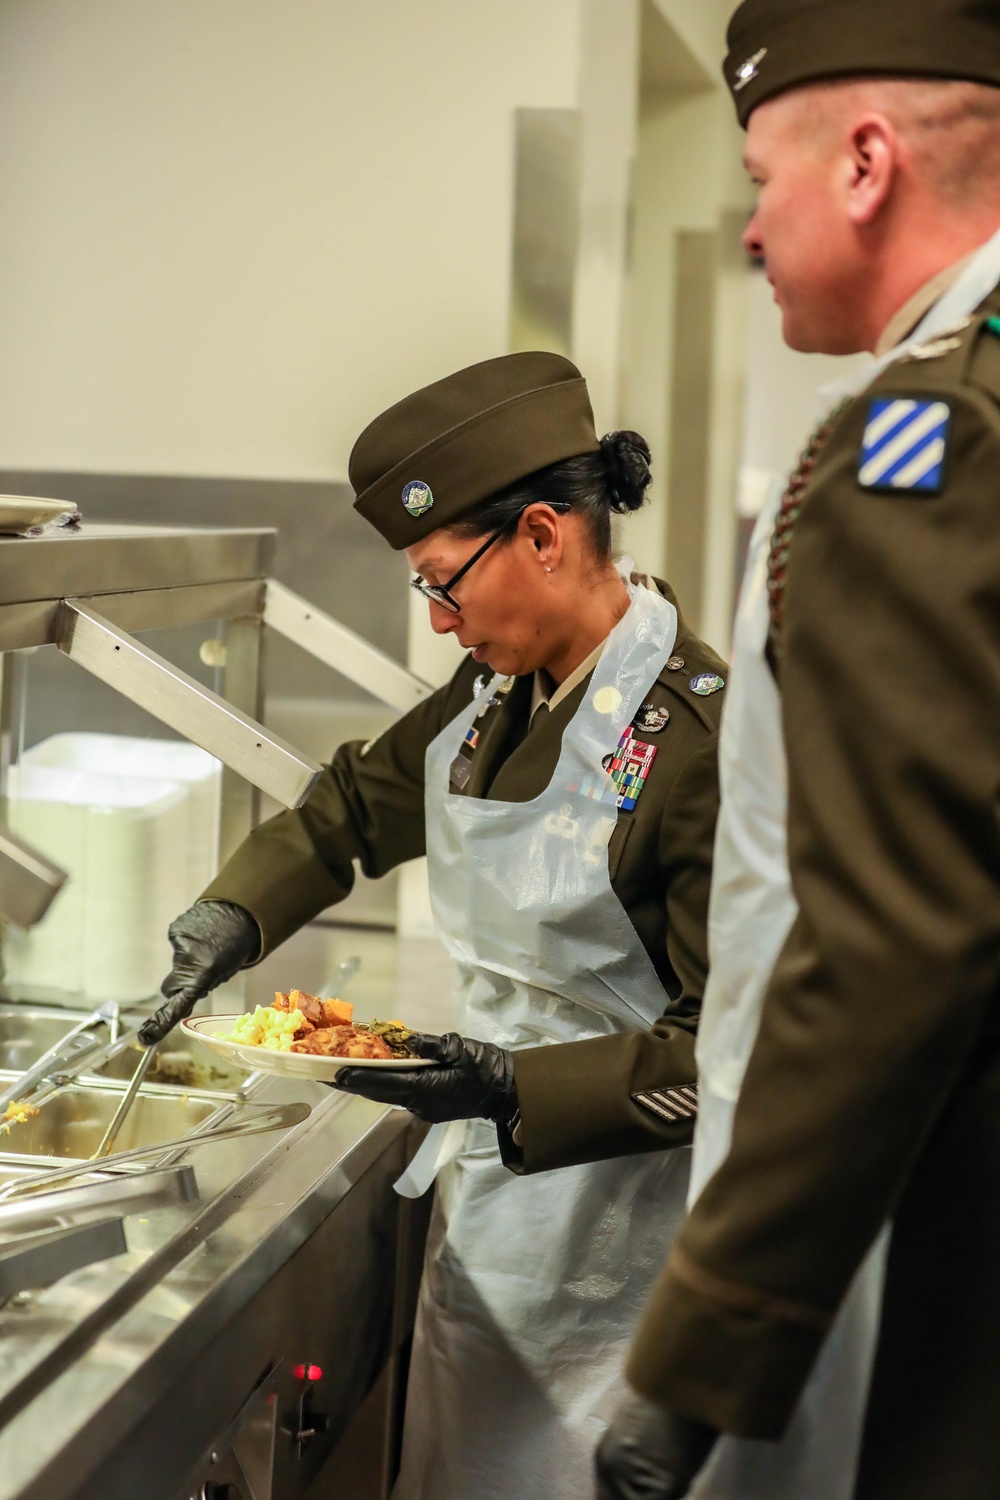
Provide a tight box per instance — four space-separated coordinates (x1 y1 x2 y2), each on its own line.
0 0 580 479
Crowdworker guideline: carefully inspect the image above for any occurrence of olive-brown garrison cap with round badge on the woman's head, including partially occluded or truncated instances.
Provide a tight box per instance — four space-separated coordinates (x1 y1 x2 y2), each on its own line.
348 353 601 552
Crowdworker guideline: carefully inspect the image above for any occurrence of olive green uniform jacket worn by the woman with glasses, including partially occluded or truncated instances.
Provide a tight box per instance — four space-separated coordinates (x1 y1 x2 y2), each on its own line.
202 584 726 1172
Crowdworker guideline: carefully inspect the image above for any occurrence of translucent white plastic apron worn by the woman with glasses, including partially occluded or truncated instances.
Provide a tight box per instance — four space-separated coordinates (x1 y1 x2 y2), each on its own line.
394 563 690 1500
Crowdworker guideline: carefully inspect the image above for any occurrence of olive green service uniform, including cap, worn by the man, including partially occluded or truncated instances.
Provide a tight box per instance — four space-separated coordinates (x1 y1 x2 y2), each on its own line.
628 0 1000 1500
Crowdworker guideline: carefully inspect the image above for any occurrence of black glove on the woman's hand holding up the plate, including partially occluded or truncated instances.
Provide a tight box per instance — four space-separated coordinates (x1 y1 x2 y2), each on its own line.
334 1032 517 1125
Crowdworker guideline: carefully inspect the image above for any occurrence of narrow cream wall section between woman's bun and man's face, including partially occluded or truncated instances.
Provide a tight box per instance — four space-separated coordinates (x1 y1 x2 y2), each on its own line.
619 0 750 651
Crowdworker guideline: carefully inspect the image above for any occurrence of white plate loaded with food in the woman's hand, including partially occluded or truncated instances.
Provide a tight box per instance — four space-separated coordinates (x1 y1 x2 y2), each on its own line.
181 990 433 1083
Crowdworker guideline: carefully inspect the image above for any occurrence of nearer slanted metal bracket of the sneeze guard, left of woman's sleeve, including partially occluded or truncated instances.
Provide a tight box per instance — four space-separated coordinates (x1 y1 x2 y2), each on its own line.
57 599 322 807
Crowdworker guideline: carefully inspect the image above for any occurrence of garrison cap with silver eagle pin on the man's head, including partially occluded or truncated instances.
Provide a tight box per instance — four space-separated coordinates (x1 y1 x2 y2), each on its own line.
724 0 1000 126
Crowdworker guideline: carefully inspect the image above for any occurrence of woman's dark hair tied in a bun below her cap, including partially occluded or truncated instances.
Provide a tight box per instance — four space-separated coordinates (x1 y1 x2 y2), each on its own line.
447 432 652 561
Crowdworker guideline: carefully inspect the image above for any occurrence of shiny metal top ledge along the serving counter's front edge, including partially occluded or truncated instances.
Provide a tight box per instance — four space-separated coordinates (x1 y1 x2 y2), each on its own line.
0 1095 409 1500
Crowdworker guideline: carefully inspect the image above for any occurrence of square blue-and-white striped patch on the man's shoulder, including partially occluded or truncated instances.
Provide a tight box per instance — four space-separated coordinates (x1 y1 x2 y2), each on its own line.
858 396 952 495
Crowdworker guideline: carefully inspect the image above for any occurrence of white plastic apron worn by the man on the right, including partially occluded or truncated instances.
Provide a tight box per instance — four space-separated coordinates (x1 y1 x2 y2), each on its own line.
691 225 1000 1500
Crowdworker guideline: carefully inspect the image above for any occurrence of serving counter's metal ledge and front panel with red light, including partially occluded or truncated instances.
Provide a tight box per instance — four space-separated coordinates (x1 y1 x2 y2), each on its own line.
0 1085 418 1500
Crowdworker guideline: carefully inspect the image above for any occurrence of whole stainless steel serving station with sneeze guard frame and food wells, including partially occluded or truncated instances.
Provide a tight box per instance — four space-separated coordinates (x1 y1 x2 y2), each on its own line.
0 525 437 1500
